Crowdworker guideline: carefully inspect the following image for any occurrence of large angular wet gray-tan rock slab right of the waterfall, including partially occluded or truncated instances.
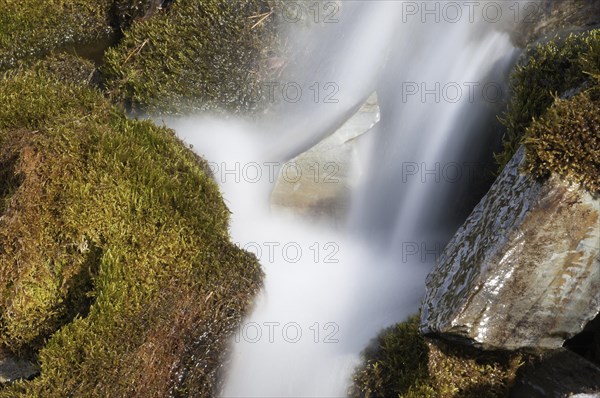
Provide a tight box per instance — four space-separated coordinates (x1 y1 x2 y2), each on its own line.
421 148 600 350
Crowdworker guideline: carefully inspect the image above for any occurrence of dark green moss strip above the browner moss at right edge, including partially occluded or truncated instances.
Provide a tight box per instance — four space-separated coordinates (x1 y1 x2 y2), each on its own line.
497 30 600 168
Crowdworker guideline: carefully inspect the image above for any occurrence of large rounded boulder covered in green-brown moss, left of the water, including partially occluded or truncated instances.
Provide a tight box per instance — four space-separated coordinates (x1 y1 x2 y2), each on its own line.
0 69 262 398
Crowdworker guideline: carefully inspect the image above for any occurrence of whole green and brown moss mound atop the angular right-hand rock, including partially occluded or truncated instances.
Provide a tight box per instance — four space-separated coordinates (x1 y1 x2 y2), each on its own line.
497 30 600 192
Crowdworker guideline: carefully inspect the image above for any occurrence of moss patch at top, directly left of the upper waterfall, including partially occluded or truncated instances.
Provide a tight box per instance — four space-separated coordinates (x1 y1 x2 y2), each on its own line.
103 0 274 114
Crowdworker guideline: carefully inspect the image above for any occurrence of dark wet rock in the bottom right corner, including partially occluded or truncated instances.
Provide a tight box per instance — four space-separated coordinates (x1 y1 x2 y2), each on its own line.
510 349 600 398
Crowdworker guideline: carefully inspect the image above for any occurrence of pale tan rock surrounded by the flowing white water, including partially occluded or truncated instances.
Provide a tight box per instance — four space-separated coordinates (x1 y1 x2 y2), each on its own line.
271 94 379 224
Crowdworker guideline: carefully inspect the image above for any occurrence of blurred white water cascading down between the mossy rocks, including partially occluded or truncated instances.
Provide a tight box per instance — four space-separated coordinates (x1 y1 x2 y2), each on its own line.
168 1 513 398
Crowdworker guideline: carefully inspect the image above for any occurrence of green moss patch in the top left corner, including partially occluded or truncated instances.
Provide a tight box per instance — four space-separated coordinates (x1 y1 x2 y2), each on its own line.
0 0 112 71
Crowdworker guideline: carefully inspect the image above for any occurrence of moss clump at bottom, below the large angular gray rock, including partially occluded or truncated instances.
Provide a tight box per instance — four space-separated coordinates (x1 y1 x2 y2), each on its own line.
350 316 522 398
